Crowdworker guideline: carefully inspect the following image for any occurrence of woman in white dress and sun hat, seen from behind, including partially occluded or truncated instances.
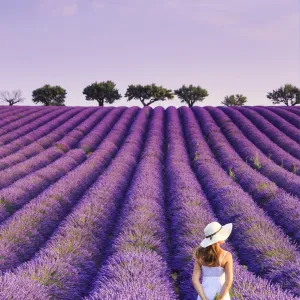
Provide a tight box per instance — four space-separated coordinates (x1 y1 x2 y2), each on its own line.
192 222 233 300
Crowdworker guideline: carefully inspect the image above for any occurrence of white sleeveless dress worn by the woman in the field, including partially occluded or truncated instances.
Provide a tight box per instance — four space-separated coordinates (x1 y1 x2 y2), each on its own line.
197 251 231 300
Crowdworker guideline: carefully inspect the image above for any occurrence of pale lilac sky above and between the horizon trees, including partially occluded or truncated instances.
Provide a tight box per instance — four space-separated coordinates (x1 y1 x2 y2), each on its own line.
0 0 300 107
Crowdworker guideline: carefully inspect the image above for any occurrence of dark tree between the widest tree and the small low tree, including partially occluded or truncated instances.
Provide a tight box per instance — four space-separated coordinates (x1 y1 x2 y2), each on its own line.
174 84 208 107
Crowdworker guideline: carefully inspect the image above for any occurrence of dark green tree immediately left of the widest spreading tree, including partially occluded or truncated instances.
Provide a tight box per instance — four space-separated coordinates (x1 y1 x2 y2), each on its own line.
82 80 122 106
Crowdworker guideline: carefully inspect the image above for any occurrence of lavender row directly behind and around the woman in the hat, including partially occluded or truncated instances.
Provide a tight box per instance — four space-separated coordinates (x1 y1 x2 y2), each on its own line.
166 107 294 300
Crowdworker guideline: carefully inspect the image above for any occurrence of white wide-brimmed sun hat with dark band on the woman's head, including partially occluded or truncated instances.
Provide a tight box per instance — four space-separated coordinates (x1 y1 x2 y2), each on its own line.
200 222 232 248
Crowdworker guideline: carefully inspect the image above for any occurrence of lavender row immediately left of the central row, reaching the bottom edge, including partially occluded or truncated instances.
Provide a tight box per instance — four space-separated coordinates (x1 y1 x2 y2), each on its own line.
8 107 151 300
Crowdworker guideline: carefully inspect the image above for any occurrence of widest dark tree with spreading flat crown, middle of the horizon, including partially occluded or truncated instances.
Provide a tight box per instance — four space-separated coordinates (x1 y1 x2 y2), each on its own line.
125 83 174 106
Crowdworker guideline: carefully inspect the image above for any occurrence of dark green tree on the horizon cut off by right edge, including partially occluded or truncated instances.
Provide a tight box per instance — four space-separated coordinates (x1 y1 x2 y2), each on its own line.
267 84 300 106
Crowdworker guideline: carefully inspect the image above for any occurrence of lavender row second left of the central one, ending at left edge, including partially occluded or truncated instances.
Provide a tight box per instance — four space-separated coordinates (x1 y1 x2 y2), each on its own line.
0 107 138 271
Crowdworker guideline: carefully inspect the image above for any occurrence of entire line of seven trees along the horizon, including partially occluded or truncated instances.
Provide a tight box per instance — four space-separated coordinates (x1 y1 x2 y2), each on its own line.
0 80 300 107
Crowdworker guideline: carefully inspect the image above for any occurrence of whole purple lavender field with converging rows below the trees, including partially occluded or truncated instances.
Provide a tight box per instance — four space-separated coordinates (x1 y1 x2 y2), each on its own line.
0 106 300 300
